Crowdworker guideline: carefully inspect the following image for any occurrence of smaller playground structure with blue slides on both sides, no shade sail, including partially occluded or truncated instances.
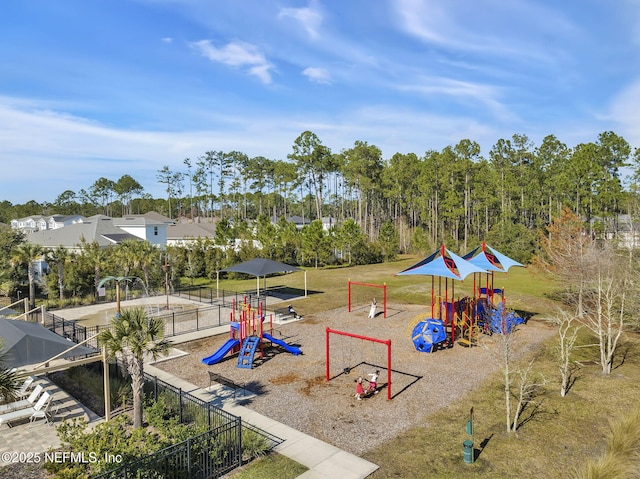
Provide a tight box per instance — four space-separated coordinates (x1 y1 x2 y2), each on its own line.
201 298 302 369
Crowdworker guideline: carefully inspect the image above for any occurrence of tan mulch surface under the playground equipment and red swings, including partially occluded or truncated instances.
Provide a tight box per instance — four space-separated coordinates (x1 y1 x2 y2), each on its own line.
155 304 554 455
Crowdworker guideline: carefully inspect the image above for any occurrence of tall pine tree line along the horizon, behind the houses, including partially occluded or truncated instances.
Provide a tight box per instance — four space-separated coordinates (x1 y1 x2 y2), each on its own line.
0 131 640 261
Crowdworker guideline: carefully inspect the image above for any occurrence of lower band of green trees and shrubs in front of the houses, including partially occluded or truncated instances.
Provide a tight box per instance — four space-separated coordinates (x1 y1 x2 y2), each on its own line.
0 215 398 308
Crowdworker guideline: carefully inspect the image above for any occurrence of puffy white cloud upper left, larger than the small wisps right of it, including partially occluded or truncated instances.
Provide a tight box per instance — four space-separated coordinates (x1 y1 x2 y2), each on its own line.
191 40 273 84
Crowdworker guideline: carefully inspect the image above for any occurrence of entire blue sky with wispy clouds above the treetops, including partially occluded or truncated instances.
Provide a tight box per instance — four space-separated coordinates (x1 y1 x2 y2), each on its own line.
0 0 640 204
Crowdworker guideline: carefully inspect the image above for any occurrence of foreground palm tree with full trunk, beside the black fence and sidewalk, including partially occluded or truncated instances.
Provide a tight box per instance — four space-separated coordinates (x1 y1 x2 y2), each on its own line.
98 307 170 428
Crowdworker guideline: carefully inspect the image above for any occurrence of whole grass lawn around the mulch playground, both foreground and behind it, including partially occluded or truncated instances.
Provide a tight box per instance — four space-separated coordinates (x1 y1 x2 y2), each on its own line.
202 257 640 478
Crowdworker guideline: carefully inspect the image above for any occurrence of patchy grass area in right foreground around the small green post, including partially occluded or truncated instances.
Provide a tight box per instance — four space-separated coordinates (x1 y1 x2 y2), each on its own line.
364 326 640 479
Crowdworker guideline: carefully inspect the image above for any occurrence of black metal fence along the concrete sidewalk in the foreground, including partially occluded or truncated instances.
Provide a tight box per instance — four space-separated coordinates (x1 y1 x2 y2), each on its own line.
94 375 282 479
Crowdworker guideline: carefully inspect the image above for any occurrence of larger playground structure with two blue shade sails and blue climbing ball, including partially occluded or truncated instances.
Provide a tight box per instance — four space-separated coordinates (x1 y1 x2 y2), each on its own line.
398 243 523 352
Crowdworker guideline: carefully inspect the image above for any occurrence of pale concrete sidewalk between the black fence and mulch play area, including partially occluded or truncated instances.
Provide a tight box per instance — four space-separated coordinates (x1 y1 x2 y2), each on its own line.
145 364 378 479
